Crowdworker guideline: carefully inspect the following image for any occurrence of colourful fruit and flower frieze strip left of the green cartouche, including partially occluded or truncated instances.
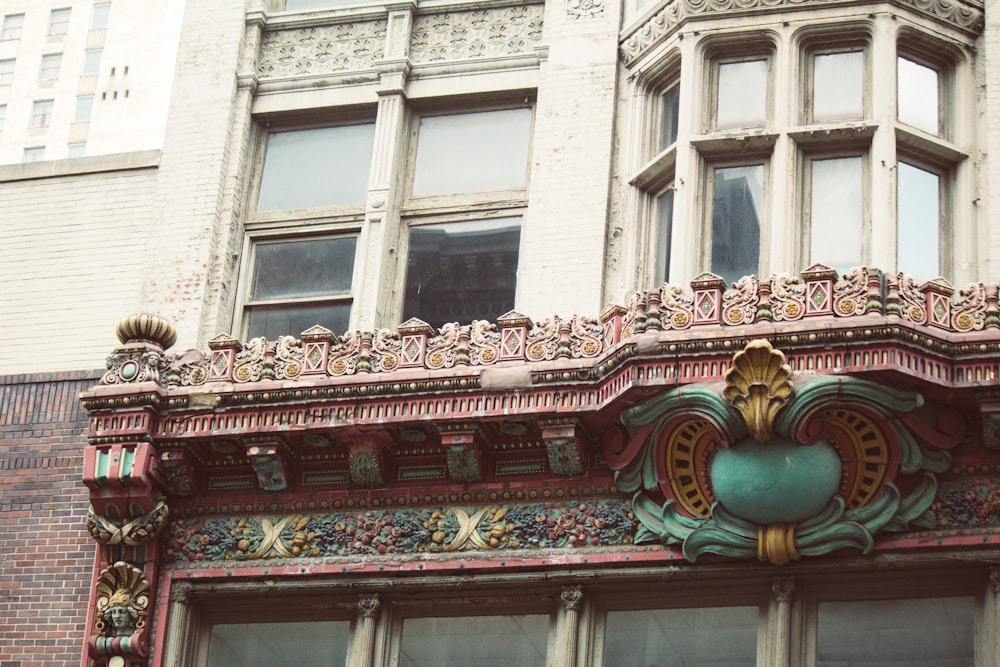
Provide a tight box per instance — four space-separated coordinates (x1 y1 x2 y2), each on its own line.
168 498 637 562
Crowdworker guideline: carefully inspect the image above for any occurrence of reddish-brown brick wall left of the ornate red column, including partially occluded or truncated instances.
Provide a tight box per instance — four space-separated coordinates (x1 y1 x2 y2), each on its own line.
0 372 100 667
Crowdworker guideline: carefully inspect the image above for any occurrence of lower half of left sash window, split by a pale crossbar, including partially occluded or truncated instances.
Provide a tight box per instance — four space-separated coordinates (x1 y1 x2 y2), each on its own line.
244 236 357 340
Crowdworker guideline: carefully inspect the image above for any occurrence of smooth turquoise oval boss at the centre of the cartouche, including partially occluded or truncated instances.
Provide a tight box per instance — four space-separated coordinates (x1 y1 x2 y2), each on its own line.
710 438 840 525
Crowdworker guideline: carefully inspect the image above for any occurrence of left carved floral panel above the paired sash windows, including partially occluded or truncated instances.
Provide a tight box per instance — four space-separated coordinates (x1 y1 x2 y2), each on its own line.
257 20 386 78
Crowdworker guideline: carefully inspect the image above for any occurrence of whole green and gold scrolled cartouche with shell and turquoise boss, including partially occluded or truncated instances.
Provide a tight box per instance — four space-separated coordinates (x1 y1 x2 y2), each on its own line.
604 340 963 565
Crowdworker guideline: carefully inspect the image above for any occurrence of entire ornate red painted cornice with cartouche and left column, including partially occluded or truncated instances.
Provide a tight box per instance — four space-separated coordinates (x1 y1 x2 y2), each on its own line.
81 266 1000 667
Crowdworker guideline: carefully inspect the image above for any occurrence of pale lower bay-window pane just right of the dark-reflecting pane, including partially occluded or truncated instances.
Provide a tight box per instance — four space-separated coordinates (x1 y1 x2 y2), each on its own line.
809 157 863 272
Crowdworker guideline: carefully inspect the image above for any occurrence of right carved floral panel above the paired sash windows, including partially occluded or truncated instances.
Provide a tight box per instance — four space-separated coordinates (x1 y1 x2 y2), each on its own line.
410 4 543 63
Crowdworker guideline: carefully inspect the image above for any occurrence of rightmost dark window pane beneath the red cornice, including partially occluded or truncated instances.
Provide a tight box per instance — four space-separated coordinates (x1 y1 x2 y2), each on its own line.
816 597 975 667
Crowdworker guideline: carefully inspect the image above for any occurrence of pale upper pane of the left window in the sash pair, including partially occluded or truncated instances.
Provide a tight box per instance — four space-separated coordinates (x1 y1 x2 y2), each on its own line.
257 123 375 211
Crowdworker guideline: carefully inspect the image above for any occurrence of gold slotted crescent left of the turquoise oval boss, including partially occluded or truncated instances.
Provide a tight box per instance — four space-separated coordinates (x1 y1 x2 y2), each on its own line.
666 419 715 518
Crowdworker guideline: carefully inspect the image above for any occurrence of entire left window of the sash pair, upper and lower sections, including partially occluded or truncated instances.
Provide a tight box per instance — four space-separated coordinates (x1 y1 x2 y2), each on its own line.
242 123 375 339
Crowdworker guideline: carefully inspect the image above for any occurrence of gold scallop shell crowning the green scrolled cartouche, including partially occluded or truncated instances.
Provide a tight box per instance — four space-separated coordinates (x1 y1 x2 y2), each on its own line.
723 339 794 442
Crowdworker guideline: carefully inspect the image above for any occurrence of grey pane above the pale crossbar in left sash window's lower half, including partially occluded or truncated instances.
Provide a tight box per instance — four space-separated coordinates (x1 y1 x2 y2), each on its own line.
251 236 357 301
